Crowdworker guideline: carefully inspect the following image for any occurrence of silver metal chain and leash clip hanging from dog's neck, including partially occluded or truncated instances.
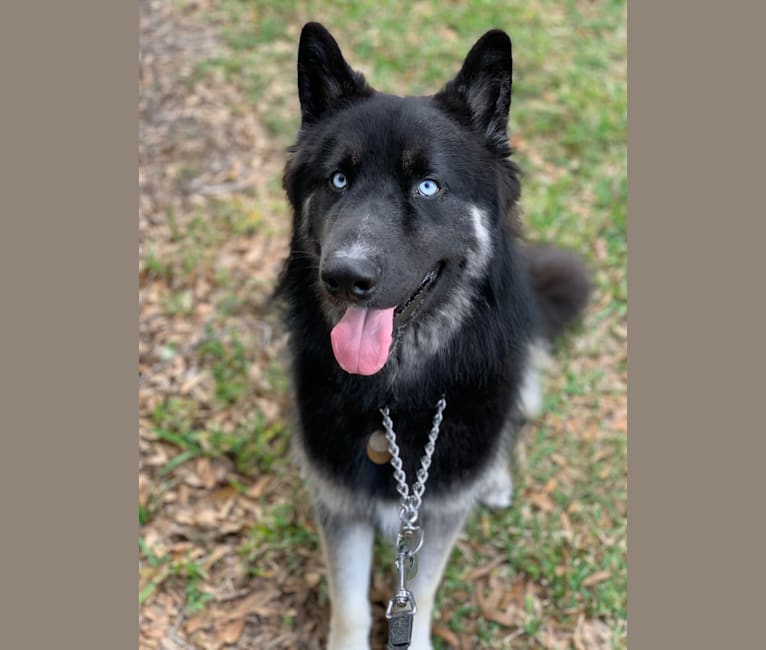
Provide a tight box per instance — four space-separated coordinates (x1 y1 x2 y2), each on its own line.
380 395 447 650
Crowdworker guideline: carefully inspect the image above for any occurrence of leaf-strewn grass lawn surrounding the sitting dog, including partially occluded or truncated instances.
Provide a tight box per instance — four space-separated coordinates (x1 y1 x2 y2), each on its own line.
139 0 627 648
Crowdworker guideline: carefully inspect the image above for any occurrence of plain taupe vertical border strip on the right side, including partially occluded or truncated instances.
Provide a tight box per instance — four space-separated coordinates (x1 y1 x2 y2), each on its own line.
628 1 766 649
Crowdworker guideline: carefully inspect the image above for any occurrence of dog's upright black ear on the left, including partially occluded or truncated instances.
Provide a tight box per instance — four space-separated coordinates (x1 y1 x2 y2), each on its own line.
298 23 372 125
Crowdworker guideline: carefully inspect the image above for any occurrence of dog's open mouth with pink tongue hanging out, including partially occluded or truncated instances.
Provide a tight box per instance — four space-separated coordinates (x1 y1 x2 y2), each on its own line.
330 263 444 375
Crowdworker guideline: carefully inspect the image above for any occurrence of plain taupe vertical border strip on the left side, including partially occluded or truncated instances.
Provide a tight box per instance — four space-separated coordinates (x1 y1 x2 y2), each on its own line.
0 1 138 650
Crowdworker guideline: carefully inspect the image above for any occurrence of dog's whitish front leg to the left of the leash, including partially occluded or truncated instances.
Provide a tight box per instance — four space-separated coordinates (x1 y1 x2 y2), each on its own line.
317 508 374 650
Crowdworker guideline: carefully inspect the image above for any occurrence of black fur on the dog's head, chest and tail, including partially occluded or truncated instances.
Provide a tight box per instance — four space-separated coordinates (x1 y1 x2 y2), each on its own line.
278 23 588 499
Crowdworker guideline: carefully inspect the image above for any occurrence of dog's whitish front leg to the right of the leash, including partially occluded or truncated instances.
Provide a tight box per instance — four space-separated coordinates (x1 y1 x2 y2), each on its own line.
409 510 470 650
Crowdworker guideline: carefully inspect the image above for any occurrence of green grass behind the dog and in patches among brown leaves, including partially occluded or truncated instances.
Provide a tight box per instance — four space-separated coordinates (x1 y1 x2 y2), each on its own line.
139 0 627 648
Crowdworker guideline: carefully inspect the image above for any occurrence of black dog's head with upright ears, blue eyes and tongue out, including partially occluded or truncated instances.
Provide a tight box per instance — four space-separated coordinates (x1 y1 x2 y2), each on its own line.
284 23 519 375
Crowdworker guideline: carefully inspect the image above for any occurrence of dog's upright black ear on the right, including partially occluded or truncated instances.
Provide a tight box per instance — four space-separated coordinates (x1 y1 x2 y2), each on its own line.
434 29 513 148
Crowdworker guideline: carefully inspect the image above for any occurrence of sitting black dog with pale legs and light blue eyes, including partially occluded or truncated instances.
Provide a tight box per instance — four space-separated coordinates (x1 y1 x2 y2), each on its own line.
276 23 590 650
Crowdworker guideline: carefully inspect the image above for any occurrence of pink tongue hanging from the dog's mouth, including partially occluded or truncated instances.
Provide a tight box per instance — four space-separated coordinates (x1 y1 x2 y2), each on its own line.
330 307 394 375
